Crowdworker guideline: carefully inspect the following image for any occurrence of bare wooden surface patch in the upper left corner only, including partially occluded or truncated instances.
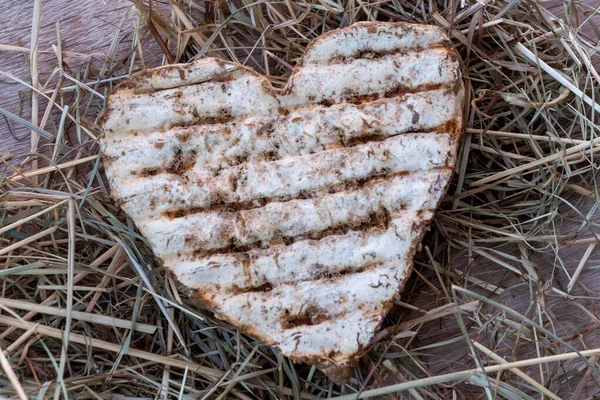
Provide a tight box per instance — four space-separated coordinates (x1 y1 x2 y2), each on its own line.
0 0 160 162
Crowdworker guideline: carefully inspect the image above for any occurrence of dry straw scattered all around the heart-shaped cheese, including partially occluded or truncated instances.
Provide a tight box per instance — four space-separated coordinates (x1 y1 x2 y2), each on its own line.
0 0 600 399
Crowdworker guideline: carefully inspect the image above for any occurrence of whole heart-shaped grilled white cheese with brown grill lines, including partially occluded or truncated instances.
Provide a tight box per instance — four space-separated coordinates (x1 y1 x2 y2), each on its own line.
102 23 464 382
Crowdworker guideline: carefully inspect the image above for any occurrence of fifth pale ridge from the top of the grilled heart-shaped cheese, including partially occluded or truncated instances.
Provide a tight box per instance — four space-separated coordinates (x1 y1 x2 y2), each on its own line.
138 171 450 257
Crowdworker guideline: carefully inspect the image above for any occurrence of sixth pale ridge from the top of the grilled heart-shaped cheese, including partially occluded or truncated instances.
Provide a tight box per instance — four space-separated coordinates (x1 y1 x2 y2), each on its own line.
173 210 433 291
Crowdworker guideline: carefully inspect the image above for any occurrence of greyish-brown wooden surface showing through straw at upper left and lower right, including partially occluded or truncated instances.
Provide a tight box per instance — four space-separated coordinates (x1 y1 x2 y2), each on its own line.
0 0 600 397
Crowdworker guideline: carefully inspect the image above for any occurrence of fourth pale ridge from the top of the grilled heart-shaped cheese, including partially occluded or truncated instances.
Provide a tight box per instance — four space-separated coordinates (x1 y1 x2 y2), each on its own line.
116 135 455 215
